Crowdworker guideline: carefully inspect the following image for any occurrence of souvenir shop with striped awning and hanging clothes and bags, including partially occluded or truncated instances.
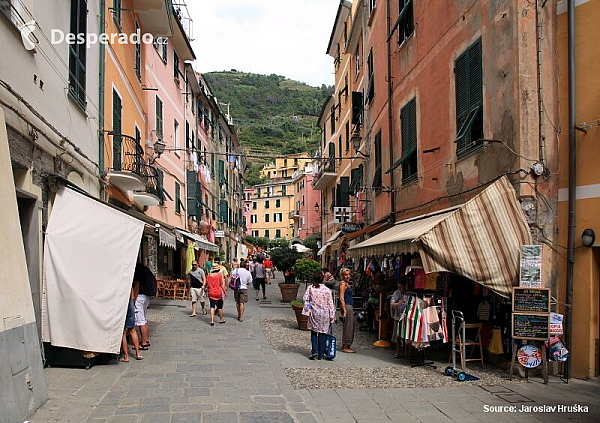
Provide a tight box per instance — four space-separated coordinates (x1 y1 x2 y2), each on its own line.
347 178 531 365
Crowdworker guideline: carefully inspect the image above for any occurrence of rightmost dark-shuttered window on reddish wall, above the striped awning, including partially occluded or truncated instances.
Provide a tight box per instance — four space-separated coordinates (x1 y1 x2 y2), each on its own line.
454 39 483 157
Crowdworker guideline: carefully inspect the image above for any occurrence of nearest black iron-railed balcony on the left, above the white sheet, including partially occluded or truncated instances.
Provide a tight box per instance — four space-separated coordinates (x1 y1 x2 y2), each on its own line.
108 132 146 191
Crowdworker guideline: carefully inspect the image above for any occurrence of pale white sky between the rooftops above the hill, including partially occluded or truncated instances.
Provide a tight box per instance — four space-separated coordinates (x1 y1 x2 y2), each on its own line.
187 0 339 87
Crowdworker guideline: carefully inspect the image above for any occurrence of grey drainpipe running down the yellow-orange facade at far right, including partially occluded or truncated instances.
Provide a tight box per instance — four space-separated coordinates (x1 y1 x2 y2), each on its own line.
565 0 577 380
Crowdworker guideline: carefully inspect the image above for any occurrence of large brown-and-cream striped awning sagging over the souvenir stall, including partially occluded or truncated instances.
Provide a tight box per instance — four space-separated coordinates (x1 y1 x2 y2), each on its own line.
349 176 531 297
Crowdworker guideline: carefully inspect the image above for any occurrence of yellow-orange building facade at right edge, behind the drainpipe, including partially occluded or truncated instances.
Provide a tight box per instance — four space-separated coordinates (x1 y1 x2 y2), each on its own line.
556 0 600 379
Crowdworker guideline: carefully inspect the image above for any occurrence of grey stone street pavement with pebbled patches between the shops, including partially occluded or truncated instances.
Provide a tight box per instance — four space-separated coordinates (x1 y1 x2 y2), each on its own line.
29 276 600 423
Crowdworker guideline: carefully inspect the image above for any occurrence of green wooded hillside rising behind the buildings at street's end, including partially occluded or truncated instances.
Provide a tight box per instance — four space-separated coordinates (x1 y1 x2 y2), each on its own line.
204 70 333 185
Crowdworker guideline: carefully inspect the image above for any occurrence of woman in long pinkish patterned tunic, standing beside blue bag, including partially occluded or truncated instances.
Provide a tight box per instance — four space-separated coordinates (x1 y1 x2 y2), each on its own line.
303 271 335 360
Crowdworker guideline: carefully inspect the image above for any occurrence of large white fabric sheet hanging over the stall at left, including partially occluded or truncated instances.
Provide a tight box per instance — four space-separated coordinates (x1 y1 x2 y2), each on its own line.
42 188 144 354
